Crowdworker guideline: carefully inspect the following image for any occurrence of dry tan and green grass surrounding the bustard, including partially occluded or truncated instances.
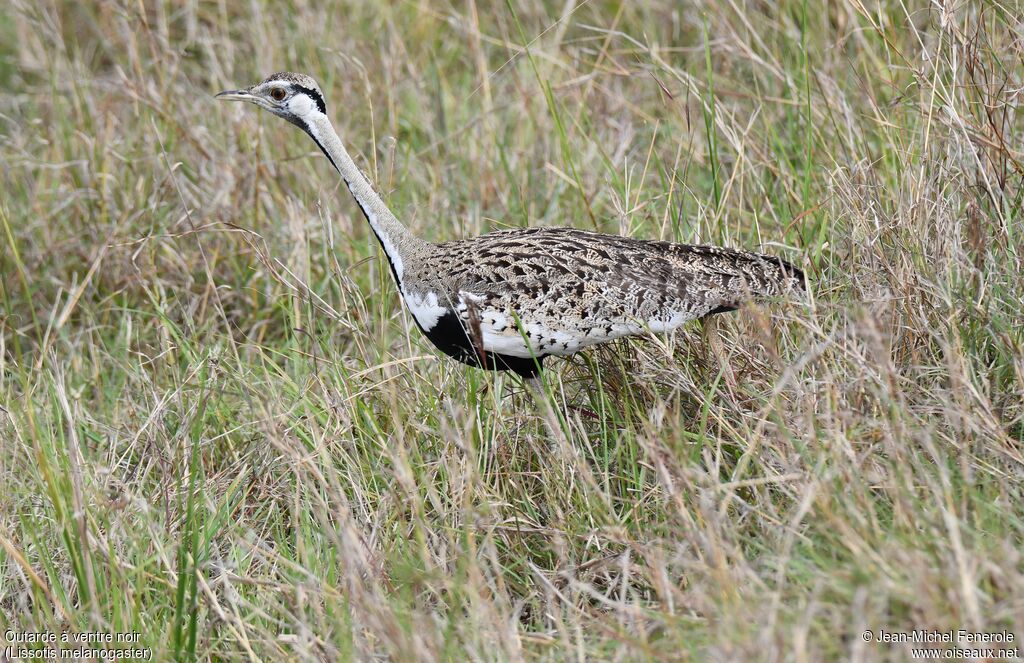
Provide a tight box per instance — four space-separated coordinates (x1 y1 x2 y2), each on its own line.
0 0 1024 660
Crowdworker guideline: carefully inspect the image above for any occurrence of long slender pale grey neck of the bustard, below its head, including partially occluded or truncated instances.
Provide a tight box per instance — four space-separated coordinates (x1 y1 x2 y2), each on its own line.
302 113 424 288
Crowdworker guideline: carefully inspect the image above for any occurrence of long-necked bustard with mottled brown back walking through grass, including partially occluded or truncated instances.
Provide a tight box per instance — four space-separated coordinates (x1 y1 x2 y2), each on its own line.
216 72 806 380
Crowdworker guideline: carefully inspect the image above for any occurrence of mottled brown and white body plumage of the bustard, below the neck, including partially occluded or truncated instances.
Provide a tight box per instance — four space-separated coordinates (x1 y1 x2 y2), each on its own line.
401 227 803 372
